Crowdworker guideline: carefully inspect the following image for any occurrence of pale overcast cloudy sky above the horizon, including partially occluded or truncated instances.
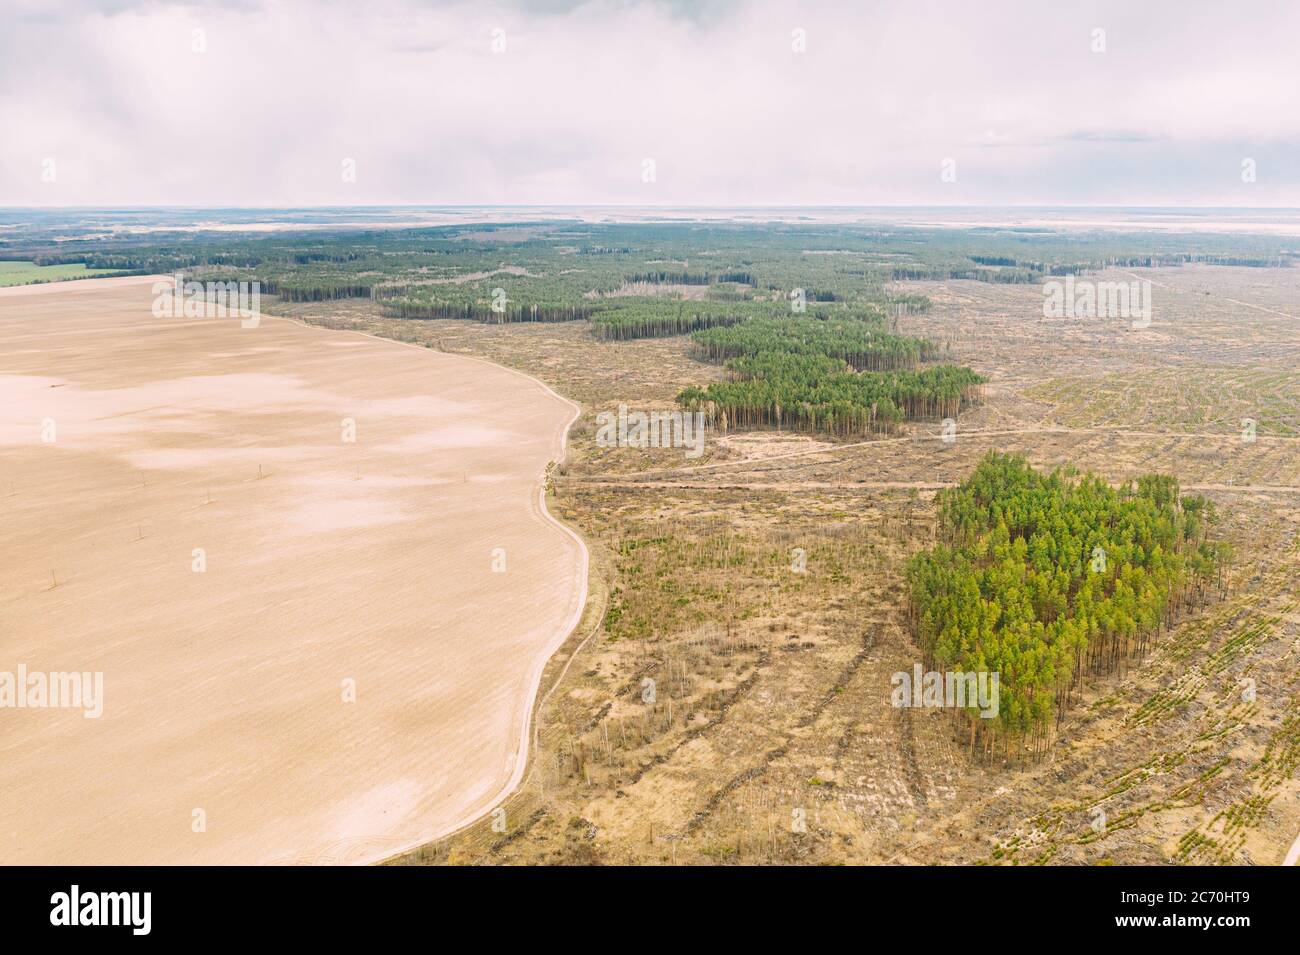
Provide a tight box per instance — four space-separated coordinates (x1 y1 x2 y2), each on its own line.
0 0 1300 207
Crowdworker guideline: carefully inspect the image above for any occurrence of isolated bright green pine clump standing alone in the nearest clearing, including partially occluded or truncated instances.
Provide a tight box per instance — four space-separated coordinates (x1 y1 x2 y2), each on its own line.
907 452 1231 760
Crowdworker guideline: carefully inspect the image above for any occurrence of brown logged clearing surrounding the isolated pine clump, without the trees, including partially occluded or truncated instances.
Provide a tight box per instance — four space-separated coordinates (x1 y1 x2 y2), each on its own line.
279 268 1300 864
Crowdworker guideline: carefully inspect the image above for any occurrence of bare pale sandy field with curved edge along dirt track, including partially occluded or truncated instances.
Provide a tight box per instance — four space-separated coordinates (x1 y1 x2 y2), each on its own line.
0 278 586 864
